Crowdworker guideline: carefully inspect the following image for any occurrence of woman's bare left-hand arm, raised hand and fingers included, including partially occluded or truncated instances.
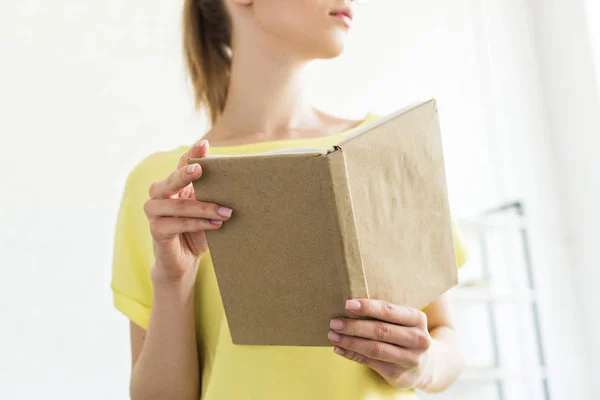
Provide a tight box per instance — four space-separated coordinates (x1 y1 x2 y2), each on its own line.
130 141 232 400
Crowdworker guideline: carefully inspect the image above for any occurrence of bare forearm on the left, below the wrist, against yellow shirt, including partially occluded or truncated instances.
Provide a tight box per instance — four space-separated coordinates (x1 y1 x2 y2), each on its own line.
131 268 200 400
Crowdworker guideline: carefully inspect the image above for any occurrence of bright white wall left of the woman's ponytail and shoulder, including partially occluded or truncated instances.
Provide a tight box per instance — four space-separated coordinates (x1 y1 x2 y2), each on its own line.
0 0 203 400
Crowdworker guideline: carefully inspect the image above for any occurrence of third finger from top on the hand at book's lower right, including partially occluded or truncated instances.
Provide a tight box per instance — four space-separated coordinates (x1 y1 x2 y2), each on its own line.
327 331 421 368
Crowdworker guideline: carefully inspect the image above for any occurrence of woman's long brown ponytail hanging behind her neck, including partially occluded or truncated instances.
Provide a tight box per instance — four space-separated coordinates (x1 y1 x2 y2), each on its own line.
183 0 231 124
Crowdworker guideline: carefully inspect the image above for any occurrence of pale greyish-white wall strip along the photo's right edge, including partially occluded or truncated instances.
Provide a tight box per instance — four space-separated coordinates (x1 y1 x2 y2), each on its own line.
532 0 600 398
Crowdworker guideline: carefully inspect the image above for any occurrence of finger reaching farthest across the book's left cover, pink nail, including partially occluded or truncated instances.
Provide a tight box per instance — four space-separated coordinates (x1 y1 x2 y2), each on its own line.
144 199 233 221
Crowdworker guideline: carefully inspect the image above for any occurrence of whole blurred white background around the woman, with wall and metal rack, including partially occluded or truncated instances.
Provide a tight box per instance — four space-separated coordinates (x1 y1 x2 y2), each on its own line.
0 0 600 400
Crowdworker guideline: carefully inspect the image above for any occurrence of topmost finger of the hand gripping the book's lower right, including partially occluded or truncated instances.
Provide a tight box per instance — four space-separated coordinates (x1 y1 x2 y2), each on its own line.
346 299 427 327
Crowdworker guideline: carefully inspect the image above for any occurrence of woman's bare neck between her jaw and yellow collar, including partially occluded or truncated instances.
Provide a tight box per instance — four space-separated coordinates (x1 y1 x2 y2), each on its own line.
214 41 317 137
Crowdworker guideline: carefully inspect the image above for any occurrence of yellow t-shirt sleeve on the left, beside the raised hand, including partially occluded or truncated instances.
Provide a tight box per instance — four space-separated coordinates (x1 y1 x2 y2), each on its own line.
111 162 154 329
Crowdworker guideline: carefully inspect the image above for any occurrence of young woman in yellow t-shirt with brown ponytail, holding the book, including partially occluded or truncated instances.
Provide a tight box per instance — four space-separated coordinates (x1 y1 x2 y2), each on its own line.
112 0 463 400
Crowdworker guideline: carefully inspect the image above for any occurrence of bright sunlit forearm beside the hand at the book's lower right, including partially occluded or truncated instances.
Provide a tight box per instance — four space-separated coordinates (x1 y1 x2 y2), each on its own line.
419 326 464 393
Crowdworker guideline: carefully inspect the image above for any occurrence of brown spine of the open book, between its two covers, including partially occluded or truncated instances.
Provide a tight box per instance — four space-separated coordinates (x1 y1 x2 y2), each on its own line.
327 149 369 299
